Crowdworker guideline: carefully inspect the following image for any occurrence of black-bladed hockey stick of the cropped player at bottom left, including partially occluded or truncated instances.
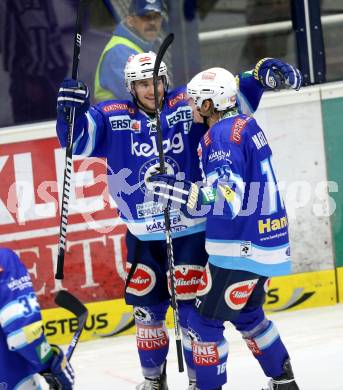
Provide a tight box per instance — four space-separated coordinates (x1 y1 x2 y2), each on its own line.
55 290 88 360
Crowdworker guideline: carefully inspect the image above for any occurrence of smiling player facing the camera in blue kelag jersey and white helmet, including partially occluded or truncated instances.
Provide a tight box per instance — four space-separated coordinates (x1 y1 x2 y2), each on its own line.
57 52 301 390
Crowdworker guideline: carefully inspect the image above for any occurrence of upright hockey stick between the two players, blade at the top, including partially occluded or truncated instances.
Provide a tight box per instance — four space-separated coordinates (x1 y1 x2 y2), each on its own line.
153 34 184 372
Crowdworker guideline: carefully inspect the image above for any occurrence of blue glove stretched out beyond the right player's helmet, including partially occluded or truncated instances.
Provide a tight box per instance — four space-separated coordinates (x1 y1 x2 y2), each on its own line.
253 58 302 91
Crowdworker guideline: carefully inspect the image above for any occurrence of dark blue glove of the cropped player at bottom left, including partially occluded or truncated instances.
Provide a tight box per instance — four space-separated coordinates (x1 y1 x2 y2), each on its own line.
40 344 74 390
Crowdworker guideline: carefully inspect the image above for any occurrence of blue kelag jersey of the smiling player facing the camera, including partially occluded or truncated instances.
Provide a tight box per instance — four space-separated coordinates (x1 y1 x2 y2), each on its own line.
57 73 263 240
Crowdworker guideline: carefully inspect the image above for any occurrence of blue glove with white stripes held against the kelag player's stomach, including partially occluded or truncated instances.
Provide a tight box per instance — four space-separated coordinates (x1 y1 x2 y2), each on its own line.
148 174 216 211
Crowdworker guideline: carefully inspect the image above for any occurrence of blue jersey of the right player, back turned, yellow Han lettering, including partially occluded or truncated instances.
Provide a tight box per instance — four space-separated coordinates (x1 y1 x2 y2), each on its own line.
198 112 291 276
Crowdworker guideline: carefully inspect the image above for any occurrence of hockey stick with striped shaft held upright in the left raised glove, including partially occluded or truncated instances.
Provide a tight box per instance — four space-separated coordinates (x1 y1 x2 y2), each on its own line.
55 0 85 279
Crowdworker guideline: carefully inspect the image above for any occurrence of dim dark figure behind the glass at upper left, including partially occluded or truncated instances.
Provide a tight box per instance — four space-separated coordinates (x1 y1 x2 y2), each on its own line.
0 0 68 124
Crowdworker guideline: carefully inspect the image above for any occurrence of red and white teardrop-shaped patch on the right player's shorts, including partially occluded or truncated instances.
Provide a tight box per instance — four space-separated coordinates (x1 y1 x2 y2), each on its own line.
224 279 258 310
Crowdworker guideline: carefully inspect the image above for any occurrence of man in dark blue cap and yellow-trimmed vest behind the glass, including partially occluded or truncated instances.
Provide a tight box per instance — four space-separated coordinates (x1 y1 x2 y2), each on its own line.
94 0 162 102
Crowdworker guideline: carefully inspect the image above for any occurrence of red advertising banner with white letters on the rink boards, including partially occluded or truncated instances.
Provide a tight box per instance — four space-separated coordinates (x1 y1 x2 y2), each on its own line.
0 138 126 308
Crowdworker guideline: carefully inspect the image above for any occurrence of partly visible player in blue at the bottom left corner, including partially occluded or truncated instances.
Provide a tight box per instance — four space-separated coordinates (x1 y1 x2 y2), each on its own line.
0 248 74 390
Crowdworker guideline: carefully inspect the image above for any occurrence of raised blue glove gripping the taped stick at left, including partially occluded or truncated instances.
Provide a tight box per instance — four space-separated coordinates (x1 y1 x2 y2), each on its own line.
57 79 89 120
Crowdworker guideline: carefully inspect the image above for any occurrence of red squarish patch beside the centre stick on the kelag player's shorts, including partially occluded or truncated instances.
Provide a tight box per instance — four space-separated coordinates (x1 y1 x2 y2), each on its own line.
168 265 204 299
